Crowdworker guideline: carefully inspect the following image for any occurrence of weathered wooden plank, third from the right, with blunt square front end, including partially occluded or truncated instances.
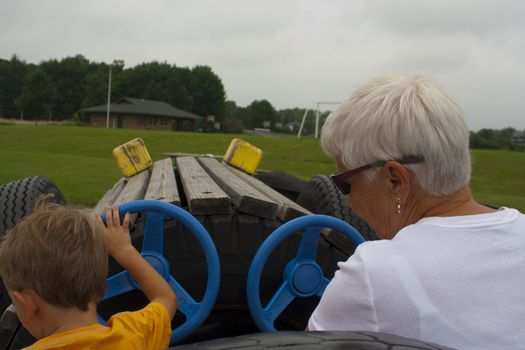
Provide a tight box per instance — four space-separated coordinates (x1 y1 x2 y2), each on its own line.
175 157 231 215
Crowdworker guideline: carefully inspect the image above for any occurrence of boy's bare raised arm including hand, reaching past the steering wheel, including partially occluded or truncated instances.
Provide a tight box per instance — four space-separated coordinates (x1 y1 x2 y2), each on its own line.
97 206 177 320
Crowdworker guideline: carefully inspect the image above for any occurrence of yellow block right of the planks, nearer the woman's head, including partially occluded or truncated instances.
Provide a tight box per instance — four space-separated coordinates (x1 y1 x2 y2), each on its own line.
223 139 262 175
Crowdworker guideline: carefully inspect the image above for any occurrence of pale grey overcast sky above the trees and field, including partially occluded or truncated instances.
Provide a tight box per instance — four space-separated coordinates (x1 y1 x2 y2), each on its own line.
0 0 525 130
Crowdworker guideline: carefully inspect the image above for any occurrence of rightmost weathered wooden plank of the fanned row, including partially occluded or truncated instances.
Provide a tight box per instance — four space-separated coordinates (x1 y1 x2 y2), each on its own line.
223 163 312 222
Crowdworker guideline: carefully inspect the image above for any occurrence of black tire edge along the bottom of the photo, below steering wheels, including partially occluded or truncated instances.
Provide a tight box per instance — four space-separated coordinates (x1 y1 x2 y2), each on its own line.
169 332 451 350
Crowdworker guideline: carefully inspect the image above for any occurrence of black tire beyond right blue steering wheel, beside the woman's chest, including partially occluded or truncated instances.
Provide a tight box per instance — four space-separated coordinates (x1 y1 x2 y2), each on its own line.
297 175 378 254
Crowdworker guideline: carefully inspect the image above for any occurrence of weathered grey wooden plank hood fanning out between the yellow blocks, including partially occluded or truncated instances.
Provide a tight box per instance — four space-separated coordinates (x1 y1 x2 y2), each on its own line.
94 156 310 222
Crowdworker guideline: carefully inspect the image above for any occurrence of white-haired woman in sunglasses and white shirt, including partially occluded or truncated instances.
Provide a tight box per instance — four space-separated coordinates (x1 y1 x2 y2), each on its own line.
308 76 525 349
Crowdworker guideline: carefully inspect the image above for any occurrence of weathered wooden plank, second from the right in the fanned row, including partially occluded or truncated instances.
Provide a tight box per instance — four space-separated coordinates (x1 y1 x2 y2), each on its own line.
199 157 277 219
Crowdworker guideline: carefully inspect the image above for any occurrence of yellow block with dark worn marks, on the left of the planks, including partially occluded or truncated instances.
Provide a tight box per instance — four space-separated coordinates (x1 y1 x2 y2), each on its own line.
113 138 153 177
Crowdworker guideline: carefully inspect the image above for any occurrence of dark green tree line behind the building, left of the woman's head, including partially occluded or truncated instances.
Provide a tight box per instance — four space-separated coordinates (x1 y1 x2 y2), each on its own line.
0 55 328 134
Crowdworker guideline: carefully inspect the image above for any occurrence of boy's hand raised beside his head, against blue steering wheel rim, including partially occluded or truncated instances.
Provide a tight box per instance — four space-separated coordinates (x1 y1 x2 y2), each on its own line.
97 206 135 258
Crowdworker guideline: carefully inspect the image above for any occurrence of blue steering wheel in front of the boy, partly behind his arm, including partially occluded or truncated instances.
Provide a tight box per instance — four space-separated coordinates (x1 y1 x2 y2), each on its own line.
99 200 221 343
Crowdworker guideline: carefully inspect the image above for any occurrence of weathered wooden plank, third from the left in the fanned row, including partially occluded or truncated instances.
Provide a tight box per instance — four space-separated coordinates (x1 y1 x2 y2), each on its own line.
144 158 180 206
